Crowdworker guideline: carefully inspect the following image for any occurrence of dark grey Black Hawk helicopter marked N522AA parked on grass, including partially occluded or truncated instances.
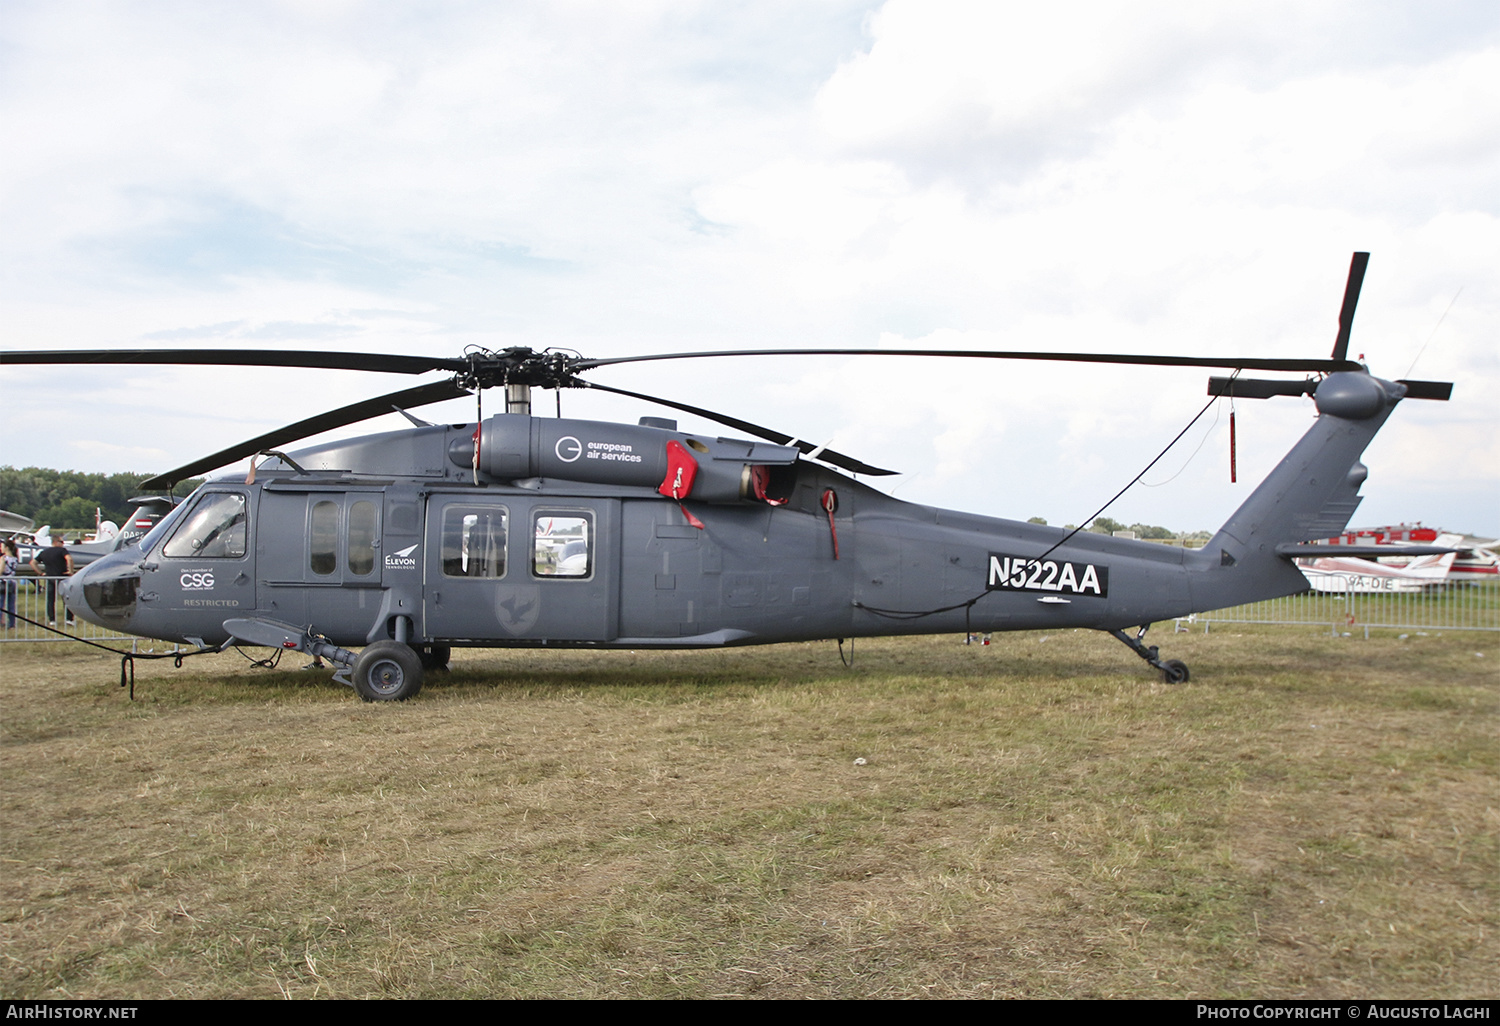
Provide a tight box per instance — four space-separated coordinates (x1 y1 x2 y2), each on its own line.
3 254 1451 701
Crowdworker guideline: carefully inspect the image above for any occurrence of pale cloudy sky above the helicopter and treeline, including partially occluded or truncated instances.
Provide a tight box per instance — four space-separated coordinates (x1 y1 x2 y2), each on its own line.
0 0 1500 537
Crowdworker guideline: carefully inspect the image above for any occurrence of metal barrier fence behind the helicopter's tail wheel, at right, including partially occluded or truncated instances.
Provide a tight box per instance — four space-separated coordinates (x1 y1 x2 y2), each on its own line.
1178 582 1500 636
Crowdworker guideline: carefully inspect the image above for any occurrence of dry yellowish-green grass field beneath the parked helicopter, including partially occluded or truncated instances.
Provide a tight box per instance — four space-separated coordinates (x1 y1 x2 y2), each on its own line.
0 627 1500 998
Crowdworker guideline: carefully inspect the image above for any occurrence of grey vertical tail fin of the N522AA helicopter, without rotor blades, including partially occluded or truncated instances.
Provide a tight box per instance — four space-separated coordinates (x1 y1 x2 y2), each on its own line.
1191 371 1407 612
